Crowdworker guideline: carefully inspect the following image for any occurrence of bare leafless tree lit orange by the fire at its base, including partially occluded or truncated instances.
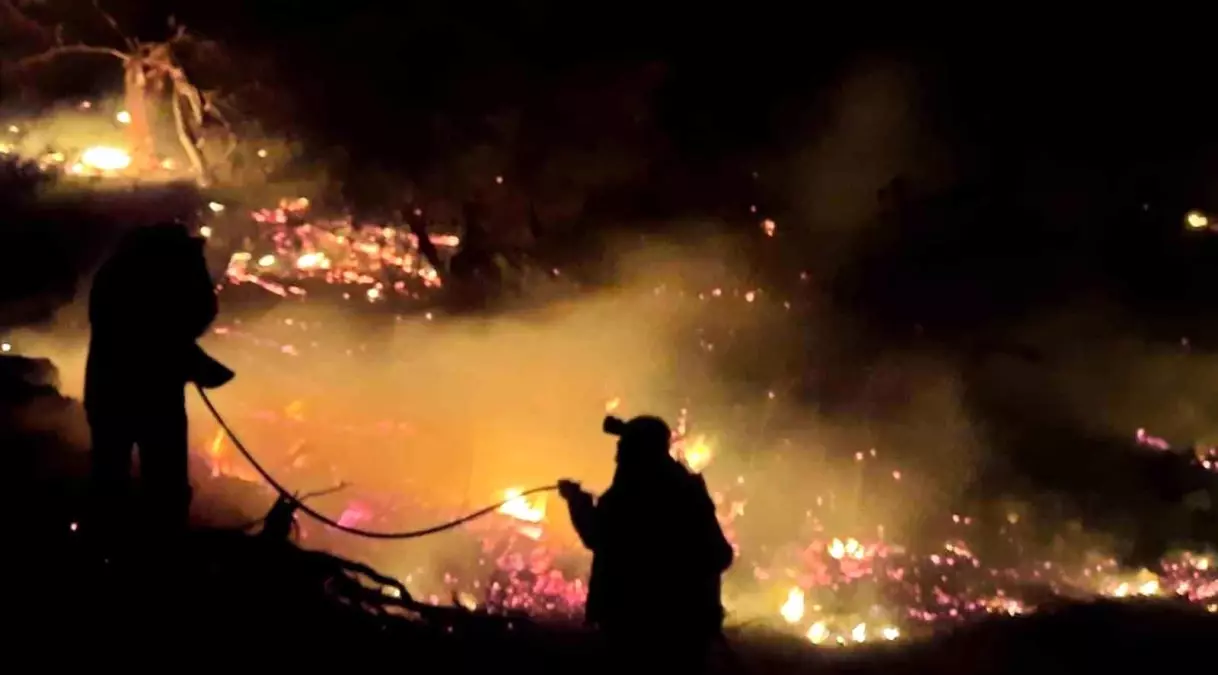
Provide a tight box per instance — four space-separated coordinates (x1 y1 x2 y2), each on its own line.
0 0 235 185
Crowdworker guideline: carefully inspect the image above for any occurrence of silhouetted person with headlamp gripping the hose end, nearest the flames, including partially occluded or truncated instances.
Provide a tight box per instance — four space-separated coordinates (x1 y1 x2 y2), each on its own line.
559 417 733 673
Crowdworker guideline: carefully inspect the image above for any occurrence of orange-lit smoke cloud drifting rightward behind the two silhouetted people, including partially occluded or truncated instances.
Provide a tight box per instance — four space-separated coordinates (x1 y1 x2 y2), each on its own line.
0 51 1213 618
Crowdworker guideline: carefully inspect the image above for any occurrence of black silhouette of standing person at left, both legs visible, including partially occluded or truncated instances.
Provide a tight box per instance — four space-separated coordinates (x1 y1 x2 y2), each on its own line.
84 223 233 539
